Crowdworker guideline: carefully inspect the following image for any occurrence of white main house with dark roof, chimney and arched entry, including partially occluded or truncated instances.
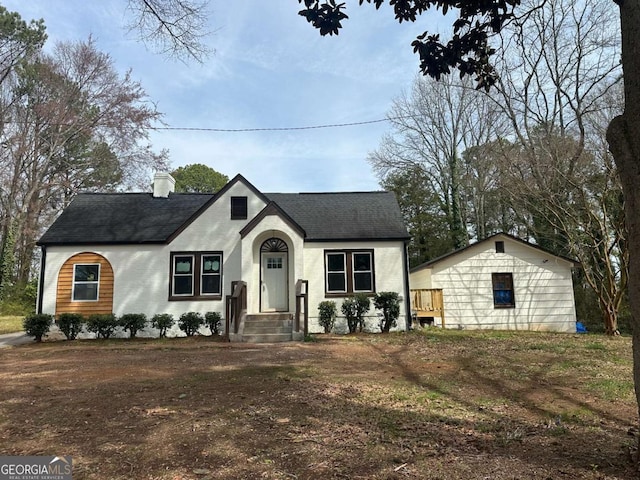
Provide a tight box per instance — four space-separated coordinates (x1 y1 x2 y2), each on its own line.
37 174 409 340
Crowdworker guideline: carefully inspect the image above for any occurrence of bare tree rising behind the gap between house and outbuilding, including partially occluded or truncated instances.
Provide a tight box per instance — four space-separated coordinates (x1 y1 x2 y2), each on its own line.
369 77 508 248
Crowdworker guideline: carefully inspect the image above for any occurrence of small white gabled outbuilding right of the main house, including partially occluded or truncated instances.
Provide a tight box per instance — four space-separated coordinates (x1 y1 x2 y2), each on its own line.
410 234 576 332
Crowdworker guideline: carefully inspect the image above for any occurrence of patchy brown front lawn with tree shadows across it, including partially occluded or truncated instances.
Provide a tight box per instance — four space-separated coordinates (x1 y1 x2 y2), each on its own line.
0 329 637 480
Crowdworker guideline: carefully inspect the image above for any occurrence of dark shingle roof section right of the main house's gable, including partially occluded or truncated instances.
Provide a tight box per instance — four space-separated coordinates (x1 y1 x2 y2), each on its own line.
265 192 409 241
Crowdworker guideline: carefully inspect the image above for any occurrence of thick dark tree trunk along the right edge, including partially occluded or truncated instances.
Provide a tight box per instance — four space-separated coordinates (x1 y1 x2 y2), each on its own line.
607 0 640 460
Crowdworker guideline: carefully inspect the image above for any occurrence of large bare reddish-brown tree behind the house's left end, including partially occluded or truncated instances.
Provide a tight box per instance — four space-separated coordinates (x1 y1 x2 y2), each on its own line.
0 39 167 283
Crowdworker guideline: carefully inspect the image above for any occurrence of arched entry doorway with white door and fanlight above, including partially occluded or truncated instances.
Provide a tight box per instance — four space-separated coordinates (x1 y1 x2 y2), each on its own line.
260 237 289 312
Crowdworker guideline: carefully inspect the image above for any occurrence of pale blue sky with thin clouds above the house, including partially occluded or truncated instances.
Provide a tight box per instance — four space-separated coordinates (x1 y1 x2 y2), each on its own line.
0 0 447 192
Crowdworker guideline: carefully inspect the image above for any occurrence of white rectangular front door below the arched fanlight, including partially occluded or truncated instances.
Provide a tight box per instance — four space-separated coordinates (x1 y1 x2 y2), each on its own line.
260 252 289 312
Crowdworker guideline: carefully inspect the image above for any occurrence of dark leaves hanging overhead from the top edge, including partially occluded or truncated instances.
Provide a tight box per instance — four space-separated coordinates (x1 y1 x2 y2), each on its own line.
298 0 521 90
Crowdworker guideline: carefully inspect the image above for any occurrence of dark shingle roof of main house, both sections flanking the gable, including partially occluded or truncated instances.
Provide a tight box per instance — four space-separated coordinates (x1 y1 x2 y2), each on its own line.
38 192 408 245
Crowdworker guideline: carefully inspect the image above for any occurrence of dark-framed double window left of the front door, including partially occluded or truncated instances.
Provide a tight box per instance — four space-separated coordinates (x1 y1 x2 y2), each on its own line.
169 252 222 300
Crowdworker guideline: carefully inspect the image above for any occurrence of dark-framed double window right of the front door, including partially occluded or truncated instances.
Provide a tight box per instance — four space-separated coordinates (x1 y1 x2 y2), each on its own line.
325 250 375 296
